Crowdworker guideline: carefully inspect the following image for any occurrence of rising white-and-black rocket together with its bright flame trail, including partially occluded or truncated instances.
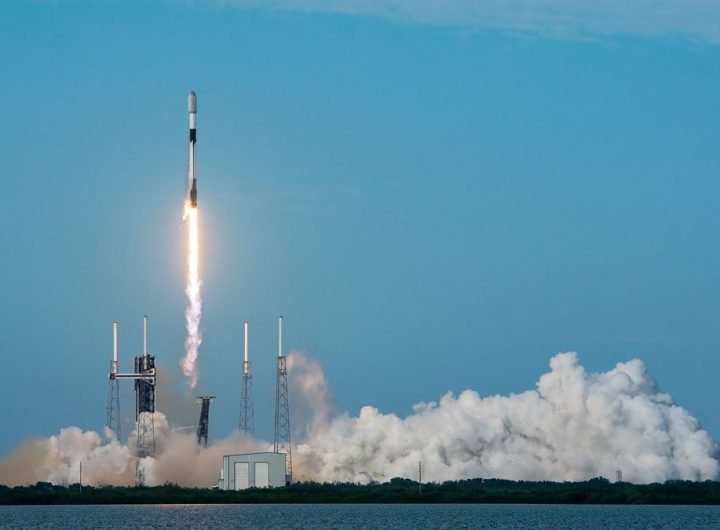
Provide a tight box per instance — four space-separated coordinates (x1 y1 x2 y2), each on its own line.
180 92 202 388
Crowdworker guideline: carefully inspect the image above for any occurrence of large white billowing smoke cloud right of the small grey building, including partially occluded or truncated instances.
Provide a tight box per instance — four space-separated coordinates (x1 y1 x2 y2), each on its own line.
291 353 719 482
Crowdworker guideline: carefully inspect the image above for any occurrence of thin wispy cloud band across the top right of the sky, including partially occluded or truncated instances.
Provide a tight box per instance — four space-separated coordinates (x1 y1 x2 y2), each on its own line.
214 0 720 43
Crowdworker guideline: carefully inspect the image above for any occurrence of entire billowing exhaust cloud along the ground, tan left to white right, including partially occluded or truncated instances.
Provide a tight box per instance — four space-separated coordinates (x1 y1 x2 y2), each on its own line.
0 353 720 486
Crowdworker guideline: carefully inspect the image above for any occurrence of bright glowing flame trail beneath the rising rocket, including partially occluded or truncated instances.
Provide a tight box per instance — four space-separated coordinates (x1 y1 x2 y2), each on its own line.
180 202 202 388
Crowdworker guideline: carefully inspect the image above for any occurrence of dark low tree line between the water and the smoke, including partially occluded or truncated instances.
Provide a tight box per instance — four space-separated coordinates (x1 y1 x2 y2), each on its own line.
0 478 720 504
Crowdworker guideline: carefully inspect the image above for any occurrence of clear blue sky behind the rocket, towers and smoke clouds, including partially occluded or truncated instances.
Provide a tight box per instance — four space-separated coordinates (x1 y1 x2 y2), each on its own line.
0 0 720 452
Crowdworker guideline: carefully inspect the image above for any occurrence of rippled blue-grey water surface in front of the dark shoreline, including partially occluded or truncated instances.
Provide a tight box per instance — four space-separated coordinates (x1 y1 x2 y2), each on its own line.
0 504 720 530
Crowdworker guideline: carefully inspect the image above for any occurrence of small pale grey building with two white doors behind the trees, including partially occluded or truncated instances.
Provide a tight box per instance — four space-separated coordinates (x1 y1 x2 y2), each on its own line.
218 453 285 490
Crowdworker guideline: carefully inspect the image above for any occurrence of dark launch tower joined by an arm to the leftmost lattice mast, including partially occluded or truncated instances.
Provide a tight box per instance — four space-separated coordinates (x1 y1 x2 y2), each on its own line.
107 315 157 484
